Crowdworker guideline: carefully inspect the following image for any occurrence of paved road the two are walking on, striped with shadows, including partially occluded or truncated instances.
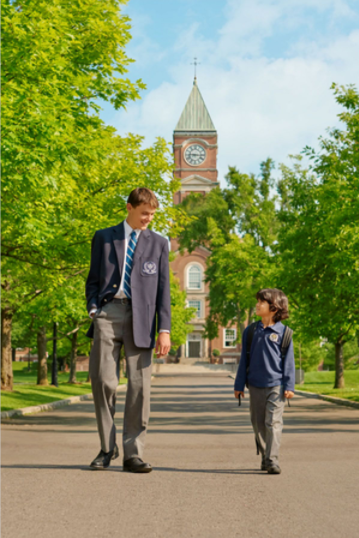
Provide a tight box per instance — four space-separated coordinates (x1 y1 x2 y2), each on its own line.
2 374 359 538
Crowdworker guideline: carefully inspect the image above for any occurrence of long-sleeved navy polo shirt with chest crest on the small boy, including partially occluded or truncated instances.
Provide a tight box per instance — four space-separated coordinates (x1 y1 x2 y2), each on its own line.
234 321 295 392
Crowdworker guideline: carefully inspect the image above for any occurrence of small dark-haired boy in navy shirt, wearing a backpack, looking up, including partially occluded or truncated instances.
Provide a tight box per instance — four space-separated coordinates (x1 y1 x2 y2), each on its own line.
234 288 295 474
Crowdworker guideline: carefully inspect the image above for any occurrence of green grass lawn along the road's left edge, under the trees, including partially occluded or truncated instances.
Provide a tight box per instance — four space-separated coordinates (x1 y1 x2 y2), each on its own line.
1 362 127 411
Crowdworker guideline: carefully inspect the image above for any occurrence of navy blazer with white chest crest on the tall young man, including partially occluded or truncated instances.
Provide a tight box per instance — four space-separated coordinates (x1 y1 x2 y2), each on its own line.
86 222 171 348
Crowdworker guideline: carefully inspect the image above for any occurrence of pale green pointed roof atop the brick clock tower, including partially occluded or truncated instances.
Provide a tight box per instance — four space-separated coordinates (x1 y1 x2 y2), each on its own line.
175 78 216 132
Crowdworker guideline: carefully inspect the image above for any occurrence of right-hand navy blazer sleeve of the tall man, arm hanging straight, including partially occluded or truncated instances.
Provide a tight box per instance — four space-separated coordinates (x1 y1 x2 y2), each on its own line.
156 240 171 331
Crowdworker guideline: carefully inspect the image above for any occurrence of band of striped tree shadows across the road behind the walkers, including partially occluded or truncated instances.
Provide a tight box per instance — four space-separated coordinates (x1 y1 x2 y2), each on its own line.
3 381 358 435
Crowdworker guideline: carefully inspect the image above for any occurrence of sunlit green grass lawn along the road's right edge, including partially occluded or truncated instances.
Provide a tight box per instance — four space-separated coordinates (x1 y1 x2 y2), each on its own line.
295 370 359 402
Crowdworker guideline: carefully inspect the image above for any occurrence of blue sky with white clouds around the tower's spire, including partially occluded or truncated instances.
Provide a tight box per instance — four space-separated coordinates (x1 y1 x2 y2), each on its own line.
102 0 359 184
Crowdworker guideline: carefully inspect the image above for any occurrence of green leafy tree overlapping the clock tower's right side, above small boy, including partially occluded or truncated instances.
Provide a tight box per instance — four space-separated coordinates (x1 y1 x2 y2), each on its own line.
179 159 278 339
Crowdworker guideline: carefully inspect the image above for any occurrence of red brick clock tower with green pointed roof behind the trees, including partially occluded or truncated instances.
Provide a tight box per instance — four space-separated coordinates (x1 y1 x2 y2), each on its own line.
171 77 237 362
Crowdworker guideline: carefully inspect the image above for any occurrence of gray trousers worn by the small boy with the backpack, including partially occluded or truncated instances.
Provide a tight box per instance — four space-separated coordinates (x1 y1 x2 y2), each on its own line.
249 385 285 465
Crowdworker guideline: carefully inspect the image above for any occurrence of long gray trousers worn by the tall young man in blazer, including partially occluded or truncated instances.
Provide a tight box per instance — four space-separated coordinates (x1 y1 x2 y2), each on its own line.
90 299 152 460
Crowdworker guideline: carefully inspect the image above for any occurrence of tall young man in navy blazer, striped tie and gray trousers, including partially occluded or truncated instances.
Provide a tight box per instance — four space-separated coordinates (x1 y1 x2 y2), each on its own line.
86 188 171 473
